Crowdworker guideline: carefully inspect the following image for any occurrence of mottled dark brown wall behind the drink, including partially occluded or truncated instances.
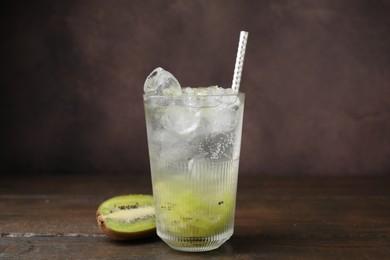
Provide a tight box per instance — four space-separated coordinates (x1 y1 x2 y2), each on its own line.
0 0 390 175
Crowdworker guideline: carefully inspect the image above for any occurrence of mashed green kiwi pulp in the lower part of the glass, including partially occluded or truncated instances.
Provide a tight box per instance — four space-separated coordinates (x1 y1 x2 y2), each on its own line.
155 185 235 237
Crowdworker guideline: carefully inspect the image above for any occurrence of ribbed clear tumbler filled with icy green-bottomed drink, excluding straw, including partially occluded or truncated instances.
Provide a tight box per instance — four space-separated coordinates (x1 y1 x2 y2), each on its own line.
144 93 244 252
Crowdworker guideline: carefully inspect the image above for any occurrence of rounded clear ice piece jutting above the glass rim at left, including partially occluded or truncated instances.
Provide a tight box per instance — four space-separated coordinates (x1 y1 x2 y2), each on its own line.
144 67 181 96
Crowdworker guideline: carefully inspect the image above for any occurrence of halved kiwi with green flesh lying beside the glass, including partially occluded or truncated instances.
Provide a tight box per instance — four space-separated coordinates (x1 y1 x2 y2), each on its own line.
96 194 156 240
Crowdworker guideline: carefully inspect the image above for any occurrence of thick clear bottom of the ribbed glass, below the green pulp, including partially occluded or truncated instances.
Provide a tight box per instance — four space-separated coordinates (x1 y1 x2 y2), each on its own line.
157 230 233 252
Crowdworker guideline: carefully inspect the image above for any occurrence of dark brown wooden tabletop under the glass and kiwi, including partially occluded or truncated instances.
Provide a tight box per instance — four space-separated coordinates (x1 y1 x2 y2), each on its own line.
0 174 390 259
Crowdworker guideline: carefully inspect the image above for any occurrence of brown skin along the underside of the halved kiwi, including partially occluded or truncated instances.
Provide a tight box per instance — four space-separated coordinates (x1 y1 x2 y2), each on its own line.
96 209 156 241
